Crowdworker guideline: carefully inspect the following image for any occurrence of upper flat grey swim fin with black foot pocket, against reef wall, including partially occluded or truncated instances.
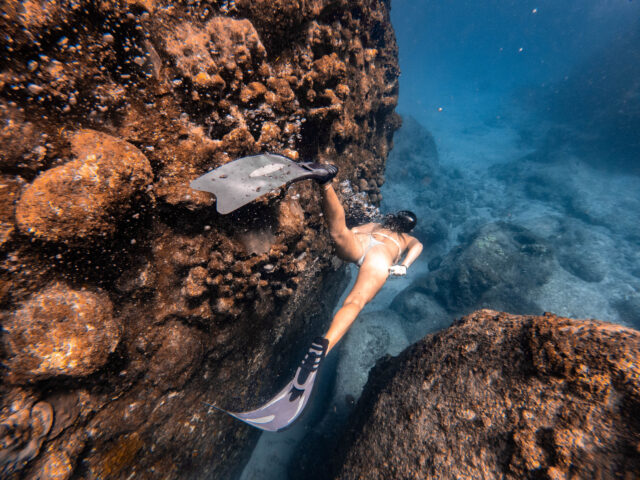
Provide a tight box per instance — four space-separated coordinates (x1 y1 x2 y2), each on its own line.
190 153 338 215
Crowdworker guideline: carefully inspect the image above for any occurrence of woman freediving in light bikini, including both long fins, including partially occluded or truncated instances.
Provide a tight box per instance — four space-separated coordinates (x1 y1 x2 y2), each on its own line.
190 153 423 432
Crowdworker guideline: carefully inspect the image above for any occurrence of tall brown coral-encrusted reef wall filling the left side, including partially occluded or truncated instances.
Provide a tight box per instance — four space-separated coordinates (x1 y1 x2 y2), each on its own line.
0 0 399 479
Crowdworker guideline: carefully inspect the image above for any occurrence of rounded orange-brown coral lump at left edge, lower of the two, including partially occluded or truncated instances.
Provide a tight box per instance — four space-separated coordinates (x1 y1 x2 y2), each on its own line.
3 284 121 382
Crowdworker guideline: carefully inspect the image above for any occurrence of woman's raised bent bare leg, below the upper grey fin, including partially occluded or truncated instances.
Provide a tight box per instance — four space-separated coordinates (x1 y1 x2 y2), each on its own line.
321 184 362 262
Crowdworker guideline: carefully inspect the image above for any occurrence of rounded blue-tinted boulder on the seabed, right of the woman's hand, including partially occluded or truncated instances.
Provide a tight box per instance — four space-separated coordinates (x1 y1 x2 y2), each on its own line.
404 222 554 318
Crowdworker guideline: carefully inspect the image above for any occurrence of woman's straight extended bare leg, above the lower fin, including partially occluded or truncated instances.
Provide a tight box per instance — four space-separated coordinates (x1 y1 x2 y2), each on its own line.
325 254 390 352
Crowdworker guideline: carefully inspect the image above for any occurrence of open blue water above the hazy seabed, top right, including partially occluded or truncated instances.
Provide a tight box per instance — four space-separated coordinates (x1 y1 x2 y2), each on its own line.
391 0 640 124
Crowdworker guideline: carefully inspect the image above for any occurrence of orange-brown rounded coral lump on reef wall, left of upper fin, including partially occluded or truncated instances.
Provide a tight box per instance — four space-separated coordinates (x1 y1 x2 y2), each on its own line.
16 130 152 243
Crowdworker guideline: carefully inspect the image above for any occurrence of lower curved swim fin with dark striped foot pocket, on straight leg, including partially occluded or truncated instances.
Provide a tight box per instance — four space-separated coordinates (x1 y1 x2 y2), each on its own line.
215 337 329 432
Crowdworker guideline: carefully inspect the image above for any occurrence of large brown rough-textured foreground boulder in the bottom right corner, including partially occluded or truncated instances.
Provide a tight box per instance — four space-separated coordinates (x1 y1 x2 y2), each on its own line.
335 310 640 479
